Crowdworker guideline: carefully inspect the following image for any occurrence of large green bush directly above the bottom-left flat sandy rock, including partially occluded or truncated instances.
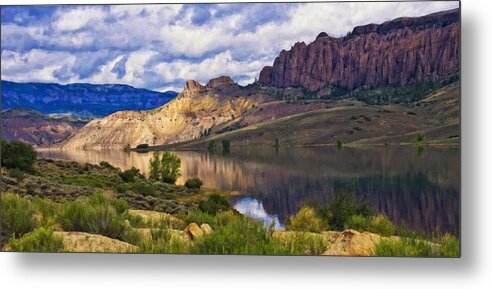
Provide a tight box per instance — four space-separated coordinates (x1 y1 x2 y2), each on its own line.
59 193 128 239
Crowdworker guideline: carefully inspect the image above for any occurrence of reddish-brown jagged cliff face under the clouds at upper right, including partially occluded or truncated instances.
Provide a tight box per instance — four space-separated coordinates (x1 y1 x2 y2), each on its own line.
259 9 460 91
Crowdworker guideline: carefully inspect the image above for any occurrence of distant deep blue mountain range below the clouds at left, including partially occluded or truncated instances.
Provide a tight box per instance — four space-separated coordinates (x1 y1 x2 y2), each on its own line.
1 81 177 118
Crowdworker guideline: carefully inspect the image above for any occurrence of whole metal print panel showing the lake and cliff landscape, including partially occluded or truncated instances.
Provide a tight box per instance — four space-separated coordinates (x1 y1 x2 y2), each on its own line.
0 1 461 257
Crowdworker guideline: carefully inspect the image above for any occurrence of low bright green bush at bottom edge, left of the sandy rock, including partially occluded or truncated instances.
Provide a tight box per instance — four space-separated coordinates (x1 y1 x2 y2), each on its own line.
9 227 65 253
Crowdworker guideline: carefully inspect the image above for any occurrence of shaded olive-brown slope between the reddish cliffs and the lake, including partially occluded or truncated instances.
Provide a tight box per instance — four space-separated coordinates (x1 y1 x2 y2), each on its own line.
163 83 460 149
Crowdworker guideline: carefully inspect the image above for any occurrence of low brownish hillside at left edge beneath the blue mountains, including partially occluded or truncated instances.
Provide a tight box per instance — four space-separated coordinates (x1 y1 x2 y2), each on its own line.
2 108 87 147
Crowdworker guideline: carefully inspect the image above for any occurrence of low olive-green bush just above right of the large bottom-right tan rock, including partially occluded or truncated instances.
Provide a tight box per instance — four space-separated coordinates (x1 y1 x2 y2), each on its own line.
345 214 396 236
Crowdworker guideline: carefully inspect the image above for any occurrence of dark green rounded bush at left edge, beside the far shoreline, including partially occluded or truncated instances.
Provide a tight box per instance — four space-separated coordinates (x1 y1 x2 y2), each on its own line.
1 140 38 171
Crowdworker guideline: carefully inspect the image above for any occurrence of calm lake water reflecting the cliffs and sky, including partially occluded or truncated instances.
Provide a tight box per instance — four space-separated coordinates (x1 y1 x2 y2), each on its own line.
40 147 460 234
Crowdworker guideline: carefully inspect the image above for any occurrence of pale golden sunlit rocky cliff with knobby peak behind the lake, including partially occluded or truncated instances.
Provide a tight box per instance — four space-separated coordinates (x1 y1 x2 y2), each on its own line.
63 76 268 149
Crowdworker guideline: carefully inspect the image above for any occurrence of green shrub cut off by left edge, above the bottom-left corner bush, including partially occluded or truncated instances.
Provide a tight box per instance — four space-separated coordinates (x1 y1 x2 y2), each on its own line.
0 193 38 238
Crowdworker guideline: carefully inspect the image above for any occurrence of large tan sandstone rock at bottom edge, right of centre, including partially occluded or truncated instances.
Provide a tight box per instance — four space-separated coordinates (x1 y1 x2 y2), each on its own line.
323 230 381 256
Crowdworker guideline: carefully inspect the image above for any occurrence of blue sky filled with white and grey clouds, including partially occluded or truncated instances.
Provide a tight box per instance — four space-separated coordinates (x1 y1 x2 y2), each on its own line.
1 1 459 91
